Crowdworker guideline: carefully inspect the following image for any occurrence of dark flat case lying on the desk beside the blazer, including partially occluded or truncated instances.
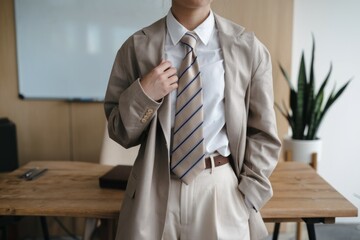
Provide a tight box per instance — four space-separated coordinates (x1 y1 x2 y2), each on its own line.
99 165 132 190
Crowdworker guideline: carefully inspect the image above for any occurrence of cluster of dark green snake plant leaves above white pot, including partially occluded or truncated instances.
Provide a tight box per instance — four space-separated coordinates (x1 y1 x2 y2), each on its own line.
277 36 351 140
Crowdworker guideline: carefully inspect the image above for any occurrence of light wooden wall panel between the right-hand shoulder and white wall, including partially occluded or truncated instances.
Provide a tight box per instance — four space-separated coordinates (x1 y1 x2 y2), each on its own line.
212 0 293 148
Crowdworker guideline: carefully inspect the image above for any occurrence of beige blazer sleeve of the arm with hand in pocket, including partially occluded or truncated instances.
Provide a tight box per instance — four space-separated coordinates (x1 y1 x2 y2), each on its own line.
239 37 281 210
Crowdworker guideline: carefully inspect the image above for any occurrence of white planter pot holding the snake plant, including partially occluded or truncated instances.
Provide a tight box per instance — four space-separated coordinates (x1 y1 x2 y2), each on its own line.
283 137 322 163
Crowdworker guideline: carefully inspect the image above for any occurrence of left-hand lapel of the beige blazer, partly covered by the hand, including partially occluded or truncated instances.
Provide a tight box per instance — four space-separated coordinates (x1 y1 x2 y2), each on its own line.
134 18 171 150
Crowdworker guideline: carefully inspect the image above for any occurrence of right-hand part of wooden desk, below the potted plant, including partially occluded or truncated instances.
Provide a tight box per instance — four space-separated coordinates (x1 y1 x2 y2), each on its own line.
261 162 358 239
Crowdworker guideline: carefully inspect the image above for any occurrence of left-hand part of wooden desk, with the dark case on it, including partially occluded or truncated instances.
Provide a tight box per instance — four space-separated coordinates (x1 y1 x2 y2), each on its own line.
0 161 124 240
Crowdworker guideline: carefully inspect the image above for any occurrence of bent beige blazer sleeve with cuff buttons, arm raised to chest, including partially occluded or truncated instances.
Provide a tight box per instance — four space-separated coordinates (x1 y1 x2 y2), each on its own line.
104 37 161 148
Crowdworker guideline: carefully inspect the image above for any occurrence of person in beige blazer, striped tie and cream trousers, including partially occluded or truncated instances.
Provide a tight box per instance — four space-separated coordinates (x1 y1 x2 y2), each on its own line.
105 0 280 240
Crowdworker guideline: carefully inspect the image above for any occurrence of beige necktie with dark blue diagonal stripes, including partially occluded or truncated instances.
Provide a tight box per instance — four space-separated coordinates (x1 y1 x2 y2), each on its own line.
171 32 205 184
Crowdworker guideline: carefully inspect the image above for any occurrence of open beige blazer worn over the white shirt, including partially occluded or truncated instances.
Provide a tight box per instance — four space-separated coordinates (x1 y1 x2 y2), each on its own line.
105 15 281 240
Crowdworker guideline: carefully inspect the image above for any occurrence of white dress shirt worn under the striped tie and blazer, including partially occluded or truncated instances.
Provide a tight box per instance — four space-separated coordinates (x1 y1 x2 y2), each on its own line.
165 10 230 156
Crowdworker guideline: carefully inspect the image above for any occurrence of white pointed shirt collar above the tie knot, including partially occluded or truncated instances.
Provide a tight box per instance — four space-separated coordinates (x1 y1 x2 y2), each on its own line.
166 10 215 45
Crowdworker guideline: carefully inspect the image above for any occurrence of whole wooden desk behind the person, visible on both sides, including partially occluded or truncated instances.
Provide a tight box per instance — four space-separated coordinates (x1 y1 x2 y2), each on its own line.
0 161 357 239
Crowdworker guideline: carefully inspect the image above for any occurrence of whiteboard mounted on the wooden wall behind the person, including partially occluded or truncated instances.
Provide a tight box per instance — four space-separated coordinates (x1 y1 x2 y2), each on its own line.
15 0 170 101
